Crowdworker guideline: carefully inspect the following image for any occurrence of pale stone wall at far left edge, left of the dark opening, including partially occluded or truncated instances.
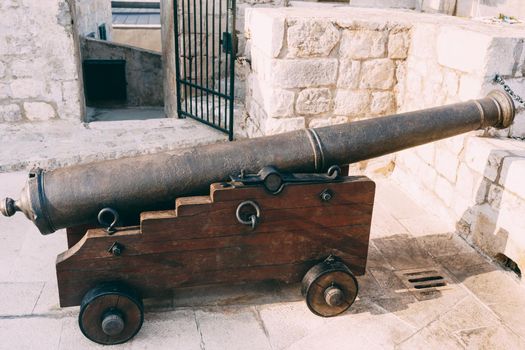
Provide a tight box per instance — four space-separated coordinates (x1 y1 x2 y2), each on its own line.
0 0 83 123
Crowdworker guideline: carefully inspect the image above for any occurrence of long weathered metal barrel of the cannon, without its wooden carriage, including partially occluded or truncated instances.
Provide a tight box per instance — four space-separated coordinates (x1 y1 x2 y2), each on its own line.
0 91 515 234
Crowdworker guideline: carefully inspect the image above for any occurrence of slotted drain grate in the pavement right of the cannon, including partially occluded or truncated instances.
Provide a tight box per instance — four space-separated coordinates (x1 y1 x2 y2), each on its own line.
395 267 451 299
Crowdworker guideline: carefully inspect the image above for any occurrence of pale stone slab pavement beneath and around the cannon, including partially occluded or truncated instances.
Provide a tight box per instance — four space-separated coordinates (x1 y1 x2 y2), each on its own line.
0 173 525 350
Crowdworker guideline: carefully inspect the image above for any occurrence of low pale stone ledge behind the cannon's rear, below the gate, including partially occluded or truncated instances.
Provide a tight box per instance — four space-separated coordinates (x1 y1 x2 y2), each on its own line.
0 117 228 173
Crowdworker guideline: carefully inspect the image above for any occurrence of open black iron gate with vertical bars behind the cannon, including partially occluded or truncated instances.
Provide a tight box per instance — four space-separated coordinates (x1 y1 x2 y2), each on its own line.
174 0 236 141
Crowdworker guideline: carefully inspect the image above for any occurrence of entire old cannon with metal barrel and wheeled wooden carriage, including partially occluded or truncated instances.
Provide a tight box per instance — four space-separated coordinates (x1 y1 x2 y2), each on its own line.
0 91 515 344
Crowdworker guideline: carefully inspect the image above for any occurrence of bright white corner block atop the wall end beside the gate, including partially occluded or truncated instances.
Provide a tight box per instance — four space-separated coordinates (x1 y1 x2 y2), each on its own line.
246 9 285 57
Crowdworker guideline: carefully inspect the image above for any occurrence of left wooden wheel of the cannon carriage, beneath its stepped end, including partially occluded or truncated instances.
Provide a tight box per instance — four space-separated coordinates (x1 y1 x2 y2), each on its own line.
78 283 144 345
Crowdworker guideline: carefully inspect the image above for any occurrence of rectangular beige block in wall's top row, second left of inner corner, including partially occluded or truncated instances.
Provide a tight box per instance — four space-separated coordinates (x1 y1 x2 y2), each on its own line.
339 30 388 59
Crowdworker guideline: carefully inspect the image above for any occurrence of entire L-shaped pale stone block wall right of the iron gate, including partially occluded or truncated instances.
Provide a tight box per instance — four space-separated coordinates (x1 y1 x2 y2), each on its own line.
246 8 525 270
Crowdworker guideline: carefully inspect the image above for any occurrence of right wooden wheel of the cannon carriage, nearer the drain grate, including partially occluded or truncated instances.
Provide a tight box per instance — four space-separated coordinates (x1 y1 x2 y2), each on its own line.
302 258 358 317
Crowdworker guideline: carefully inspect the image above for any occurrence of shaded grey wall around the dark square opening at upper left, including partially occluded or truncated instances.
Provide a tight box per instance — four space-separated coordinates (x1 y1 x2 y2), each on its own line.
81 38 164 106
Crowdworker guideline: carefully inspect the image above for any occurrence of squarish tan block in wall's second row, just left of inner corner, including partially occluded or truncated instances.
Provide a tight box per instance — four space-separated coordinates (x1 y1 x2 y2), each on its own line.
359 58 395 90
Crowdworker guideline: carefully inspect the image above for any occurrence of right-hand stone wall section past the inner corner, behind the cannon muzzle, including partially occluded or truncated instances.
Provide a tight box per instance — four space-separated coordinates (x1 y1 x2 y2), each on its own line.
393 18 525 269
